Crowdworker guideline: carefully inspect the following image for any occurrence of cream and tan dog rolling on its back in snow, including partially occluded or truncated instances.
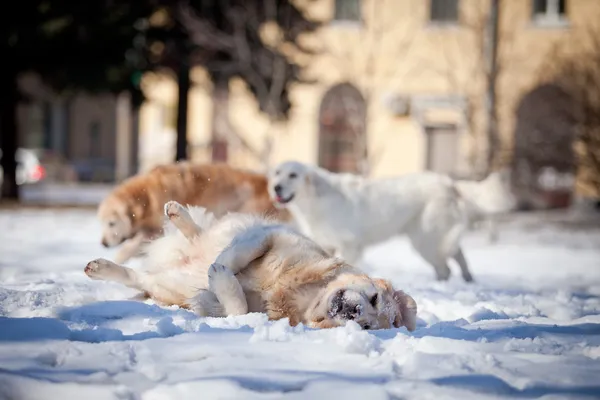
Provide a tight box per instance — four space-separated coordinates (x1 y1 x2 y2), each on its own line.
85 202 417 331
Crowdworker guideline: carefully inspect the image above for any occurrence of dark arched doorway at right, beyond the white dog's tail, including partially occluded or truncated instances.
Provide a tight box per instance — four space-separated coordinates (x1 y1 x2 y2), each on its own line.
511 84 576 208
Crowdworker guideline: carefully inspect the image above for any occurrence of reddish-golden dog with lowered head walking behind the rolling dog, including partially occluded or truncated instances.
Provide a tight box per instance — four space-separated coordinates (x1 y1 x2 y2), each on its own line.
98 162 291 263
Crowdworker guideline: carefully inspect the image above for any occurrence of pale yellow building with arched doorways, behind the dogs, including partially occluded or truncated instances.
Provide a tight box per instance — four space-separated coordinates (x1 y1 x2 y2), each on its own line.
140 0 600 206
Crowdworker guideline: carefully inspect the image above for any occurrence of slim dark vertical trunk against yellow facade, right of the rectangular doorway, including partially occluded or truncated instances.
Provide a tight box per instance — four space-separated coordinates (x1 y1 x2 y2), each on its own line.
484 0 500 175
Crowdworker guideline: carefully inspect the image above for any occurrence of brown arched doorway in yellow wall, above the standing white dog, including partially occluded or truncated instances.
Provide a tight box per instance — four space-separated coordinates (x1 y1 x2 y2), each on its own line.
319 83 367 173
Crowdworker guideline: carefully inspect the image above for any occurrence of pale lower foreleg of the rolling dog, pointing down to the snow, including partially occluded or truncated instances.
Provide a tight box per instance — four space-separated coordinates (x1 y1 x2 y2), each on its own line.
208 263 248 315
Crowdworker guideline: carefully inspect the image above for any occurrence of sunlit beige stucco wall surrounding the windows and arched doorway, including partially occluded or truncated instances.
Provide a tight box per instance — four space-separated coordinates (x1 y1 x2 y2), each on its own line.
141 0 600 188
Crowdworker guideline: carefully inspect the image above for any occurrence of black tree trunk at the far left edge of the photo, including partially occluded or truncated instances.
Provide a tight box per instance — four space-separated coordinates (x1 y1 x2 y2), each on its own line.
0 73 19 200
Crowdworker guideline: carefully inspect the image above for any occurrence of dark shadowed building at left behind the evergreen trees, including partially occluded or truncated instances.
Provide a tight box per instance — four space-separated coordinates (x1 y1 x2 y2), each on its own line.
17 75 138 182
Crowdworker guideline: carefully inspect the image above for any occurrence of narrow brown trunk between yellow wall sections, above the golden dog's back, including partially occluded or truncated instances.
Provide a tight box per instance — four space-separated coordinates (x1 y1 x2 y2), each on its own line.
211 79 232 162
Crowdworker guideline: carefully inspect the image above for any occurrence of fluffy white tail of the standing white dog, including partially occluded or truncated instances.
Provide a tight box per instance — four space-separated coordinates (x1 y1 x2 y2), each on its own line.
454 171 516 215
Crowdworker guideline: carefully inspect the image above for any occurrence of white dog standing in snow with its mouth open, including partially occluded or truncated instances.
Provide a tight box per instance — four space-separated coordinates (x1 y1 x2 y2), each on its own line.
269 161 506 282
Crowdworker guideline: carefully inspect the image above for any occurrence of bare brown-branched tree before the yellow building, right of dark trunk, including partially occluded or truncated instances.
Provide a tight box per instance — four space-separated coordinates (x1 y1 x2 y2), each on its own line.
177 0 317 167
